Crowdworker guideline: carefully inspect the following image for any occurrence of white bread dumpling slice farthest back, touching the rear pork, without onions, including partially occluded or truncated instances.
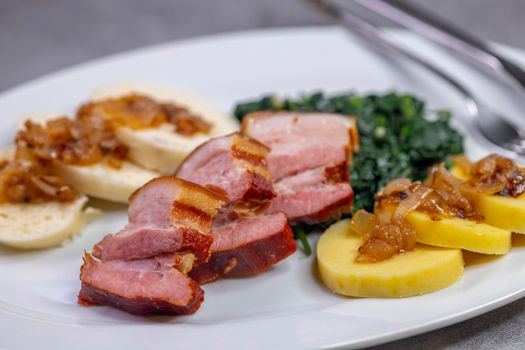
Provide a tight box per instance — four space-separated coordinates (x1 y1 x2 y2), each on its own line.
88 84 238 175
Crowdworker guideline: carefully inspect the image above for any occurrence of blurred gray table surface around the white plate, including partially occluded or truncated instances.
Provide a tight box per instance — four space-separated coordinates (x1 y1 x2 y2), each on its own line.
0 0 525 349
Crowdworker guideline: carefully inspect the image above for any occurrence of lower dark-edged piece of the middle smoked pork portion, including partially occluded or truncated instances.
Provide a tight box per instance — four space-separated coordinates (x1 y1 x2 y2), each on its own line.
189 213 296 284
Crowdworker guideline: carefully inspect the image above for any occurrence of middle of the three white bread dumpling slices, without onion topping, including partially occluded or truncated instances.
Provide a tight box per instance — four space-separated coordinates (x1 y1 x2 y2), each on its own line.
19 114 159 203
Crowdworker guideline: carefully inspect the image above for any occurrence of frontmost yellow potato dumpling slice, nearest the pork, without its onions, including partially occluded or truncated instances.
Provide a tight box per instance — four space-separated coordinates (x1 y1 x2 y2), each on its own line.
317 220 464 298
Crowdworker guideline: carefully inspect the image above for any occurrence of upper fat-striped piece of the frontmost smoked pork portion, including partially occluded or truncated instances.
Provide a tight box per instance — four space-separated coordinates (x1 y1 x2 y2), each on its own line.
93 176 226 261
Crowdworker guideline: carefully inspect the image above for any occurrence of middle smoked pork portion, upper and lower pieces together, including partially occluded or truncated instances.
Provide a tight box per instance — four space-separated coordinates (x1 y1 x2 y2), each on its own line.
176 133 296 283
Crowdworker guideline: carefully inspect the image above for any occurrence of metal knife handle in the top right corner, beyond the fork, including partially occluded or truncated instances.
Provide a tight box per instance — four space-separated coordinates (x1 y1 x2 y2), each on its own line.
354 0 525 95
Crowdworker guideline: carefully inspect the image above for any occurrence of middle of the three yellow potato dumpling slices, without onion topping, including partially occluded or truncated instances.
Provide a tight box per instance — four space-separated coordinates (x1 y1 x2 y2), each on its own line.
407 212 512 254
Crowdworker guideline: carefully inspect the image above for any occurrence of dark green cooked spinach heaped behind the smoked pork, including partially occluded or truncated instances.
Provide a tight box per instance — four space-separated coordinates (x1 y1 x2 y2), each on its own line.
234 92 463 252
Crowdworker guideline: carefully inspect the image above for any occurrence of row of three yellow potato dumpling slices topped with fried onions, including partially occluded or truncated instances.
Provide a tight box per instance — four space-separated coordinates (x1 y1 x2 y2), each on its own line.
317 156 525 298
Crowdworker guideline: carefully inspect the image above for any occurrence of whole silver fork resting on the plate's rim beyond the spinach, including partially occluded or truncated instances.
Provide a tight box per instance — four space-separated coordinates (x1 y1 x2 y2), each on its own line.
307 0 525 160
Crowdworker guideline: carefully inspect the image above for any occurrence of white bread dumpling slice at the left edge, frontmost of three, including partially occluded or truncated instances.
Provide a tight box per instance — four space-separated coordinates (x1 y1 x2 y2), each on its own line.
0 150 99 249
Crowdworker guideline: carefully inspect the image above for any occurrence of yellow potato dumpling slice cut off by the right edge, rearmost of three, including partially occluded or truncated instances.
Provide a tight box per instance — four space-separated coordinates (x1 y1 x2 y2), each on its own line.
450 166 525 234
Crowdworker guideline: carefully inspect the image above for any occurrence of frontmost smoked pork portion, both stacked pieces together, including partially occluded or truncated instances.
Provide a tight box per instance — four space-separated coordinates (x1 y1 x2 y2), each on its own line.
78 176 223 315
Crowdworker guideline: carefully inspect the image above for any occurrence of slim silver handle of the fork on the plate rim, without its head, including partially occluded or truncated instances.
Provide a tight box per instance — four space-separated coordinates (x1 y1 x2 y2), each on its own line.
310 0 479 116
